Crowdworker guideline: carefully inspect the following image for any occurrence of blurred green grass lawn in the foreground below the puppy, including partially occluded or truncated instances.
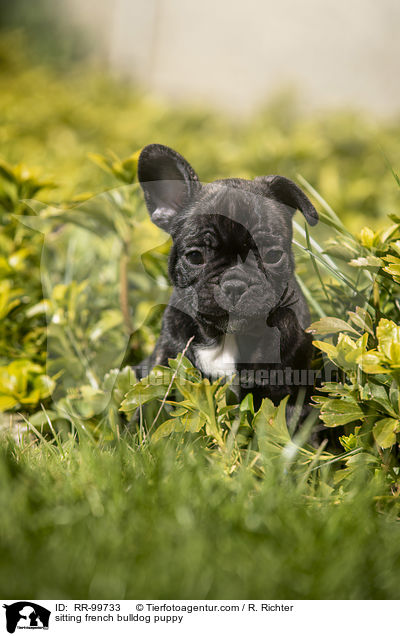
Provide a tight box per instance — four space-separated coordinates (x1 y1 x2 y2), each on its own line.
0 436 400 599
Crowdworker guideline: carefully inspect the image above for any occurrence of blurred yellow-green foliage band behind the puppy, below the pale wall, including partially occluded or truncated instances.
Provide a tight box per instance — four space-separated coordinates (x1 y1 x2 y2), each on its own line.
0 33 400 230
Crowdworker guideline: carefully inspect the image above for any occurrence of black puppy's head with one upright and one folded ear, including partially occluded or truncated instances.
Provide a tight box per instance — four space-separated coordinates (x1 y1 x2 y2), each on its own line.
138 144 318 333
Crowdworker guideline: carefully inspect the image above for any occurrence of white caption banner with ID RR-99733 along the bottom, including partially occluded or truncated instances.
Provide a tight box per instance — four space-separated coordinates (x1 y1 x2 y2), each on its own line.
0 600 400 636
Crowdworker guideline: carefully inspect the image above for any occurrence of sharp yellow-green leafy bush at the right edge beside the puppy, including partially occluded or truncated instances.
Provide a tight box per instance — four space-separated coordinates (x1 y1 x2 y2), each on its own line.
311 216 400 491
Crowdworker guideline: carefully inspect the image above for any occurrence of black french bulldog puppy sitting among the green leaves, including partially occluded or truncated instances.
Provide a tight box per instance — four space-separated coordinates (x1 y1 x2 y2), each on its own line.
135 144 318 406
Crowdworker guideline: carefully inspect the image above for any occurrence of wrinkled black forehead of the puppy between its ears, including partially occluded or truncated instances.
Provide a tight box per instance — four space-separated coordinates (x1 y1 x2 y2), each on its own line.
182 183 292 241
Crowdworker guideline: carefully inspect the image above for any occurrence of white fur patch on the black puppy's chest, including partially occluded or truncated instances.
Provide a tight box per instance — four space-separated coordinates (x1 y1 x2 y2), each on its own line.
196 334 239 378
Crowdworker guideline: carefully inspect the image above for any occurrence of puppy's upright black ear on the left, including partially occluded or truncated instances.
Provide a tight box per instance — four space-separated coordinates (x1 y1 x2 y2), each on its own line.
138 144 200 232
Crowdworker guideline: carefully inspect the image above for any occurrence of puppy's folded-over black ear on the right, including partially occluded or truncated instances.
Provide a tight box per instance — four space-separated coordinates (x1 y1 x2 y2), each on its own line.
254 175 319 225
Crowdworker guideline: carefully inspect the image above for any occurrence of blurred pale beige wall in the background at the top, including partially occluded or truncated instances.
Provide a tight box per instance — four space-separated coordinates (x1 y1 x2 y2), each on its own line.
58 0 400 114
